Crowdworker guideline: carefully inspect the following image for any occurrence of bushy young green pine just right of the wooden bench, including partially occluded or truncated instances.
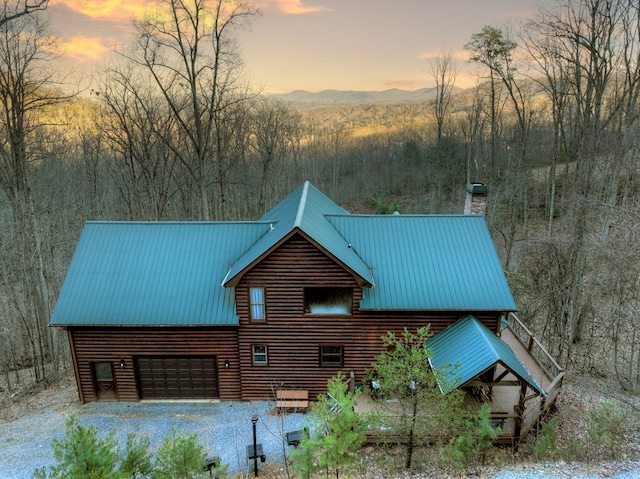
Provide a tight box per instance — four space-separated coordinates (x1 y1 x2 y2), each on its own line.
292 373 365 478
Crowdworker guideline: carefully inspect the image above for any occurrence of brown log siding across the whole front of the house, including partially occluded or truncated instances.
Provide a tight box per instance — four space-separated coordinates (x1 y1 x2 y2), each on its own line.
68 234 501 402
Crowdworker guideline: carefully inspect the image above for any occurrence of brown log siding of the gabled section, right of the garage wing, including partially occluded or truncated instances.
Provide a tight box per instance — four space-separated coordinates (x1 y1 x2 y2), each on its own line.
238 234 500 399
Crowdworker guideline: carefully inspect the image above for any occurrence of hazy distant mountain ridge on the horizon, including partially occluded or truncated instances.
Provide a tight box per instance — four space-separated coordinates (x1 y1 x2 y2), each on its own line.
270 88 436 107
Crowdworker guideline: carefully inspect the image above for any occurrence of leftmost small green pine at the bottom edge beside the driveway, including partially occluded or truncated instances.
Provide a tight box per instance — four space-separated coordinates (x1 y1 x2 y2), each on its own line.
34 416 118 479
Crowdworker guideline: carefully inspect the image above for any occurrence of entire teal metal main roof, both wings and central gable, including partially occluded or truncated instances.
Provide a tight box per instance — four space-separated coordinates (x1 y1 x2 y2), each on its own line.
51 182 516 326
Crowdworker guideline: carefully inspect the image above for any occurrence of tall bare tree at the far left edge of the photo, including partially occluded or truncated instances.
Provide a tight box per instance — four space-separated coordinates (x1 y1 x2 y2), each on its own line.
0 3 68 380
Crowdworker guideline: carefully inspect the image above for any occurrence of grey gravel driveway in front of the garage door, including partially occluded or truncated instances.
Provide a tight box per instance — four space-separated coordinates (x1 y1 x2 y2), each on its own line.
0 401 306 479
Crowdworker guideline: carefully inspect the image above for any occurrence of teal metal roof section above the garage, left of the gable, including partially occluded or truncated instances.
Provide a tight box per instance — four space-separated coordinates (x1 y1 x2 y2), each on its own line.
51 222 269 326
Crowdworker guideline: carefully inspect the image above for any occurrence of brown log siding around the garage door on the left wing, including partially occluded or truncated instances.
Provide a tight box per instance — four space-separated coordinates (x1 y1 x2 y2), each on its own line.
69 328 241 402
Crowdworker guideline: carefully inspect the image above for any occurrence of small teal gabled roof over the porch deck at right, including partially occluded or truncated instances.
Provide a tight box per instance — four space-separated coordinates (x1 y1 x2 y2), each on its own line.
426 316 545 395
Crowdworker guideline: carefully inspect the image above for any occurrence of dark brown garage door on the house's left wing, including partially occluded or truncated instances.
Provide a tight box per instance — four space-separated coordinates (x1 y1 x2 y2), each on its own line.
136 356 219 399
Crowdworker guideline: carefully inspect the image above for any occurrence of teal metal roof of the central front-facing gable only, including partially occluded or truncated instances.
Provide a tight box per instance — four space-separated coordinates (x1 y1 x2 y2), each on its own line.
223 181 374 286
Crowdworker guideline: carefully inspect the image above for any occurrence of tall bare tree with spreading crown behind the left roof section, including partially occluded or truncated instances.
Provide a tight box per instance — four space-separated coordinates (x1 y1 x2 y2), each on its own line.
123 0 256 220
